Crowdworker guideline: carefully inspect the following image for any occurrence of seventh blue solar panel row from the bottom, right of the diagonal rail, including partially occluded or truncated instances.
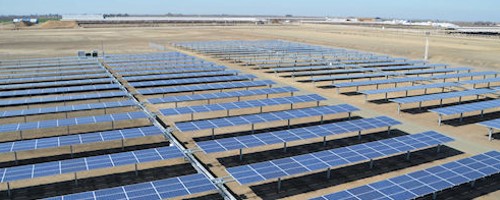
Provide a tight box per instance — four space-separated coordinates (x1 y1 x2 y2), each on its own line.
138 80 276 95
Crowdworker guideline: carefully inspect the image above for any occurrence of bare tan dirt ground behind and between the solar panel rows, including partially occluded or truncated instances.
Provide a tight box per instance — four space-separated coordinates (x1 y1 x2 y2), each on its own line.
0 25 500 199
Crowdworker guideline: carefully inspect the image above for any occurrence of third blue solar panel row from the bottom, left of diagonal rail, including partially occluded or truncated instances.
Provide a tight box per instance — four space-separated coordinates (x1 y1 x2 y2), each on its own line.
0 126 163 153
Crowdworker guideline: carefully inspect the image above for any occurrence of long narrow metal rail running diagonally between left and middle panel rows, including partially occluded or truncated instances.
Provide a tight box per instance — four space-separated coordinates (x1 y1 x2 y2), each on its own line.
99 58 236 200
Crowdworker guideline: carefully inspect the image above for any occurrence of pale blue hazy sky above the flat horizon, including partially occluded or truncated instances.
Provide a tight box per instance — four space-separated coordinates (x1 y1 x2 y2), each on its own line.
0 0 500 22
